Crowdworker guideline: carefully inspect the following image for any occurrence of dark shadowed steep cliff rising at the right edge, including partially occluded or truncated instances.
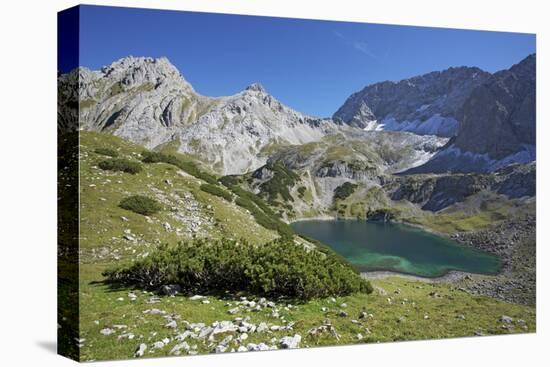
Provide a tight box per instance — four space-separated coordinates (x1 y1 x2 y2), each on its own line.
409 55 536 173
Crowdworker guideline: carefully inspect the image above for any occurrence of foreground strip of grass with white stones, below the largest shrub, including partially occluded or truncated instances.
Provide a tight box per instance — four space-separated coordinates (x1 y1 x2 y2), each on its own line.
81 272 535 360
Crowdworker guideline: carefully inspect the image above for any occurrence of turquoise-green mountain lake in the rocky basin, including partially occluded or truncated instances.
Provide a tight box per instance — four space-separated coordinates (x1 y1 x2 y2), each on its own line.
291 220 500 277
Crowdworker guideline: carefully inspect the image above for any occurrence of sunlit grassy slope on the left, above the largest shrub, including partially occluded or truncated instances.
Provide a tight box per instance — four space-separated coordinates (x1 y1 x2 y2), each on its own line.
80 133 275 255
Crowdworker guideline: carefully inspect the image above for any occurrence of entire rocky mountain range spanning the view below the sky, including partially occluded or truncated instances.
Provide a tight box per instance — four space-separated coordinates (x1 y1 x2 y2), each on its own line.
58 55 536 190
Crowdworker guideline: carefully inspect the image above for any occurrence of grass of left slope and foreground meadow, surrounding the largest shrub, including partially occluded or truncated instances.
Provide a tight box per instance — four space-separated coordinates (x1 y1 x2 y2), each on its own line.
76 133 535 360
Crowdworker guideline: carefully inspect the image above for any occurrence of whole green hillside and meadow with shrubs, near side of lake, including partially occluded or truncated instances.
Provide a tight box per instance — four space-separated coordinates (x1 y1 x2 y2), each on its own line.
67 132 536 361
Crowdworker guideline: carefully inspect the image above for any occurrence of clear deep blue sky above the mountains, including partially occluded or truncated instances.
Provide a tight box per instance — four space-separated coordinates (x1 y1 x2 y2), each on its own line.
67 6 535 116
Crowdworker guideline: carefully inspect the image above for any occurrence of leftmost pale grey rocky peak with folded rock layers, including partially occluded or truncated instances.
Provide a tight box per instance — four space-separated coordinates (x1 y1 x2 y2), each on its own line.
72 57 207 148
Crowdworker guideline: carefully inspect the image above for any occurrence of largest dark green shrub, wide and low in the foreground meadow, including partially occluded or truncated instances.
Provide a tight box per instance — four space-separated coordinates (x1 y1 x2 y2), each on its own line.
104 239 372 301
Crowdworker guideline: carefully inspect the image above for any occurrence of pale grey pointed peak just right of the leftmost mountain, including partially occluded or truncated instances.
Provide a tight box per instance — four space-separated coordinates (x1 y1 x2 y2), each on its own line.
178 83 338 175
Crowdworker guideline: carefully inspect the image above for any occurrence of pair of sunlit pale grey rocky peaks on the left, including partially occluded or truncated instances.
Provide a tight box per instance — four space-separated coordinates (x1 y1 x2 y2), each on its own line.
62 57 337 174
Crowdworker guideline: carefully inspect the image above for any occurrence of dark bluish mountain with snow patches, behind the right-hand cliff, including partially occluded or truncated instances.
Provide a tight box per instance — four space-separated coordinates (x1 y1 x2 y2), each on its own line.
333 67 490 137
